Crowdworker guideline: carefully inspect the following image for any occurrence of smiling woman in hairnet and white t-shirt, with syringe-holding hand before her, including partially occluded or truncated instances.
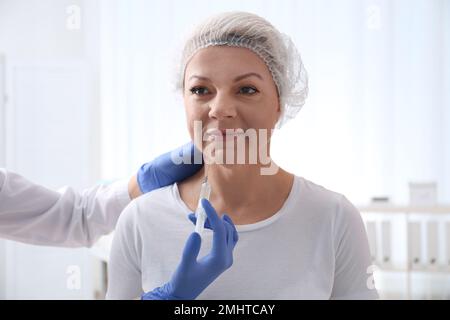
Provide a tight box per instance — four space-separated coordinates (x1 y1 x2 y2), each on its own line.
107 12 377 299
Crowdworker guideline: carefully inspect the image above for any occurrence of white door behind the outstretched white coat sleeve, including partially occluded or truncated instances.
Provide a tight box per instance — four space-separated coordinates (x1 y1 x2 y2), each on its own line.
0 60 97 299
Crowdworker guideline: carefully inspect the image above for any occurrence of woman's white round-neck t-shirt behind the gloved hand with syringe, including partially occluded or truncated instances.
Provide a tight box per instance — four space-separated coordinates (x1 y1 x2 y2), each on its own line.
106 176 378 299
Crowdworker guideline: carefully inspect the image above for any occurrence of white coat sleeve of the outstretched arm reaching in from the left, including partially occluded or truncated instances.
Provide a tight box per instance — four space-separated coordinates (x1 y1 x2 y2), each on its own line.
0 168 130 247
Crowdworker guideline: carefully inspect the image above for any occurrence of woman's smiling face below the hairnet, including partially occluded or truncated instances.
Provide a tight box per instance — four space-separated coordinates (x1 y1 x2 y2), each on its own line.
183 46 280 164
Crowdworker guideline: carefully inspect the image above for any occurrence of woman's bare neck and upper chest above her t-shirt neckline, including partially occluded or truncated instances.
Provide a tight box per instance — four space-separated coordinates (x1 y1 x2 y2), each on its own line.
180 160 293 224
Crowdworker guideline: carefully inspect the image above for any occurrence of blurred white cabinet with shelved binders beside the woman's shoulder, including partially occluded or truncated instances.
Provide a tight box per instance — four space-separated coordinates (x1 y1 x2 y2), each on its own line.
359 206 450 299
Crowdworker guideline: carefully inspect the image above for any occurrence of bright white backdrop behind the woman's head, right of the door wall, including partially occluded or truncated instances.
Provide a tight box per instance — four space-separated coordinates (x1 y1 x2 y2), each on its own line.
102 0 450 205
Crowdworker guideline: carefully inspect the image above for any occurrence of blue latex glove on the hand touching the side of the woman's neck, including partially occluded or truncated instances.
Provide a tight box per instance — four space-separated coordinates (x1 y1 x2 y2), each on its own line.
137 142 203 193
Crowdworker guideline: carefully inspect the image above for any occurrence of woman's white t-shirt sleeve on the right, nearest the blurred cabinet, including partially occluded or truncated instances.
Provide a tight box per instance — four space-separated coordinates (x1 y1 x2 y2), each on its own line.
331 196 379 300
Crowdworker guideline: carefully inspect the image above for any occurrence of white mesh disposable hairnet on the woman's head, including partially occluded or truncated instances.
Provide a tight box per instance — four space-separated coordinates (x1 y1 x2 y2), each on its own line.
177 11 308 128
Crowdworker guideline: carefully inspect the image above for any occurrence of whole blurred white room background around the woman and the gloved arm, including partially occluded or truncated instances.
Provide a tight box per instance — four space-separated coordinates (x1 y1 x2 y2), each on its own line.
0 0 450 299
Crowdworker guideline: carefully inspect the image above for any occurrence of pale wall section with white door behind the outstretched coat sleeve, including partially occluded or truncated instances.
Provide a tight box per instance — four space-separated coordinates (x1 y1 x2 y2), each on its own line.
0 0 99 299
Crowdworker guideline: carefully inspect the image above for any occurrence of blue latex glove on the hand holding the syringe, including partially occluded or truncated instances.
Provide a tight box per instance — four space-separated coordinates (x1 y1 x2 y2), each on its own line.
141 199 239 300
